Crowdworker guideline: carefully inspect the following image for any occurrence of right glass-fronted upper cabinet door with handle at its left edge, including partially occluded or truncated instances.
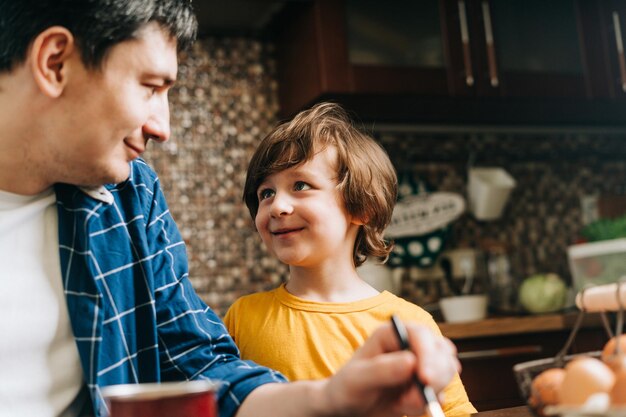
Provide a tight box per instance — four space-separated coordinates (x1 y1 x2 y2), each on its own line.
468 0 594 97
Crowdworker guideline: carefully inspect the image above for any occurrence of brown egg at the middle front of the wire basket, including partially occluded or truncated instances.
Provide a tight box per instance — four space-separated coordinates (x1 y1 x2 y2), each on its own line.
558 357 615 405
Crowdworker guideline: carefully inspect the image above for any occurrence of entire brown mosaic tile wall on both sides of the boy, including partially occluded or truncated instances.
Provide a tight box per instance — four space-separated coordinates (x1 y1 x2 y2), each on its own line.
145 38 626 314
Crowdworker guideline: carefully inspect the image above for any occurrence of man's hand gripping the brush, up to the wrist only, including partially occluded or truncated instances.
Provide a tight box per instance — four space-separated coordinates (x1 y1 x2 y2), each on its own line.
316 324 461 417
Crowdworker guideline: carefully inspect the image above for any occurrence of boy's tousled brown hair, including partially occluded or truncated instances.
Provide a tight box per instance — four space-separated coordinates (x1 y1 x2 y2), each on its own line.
243 102 398 266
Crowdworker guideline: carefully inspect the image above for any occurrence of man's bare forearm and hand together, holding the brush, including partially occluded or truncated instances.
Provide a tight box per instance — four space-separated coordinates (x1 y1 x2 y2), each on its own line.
237 324 461 417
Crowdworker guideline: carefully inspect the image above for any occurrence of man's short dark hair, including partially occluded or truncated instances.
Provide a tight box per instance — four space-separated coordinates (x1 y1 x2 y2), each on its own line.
0 0 197 72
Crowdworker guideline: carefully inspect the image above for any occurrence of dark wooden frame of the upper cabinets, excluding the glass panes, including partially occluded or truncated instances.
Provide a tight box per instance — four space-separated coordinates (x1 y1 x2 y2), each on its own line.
273 0 626 126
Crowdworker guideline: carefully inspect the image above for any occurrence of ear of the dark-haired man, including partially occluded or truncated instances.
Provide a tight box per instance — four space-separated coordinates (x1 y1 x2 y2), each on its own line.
29 26 77 98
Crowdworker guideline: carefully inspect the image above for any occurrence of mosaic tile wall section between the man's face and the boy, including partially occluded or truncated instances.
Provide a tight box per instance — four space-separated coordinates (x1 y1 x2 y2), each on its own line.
145 39 286 314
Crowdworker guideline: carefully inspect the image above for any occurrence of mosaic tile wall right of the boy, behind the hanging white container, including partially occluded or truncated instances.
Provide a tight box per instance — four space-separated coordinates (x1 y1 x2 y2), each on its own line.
376 131 626 301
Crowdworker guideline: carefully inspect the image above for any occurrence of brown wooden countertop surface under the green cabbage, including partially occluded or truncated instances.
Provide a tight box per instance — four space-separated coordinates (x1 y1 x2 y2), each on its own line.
438 311 602 340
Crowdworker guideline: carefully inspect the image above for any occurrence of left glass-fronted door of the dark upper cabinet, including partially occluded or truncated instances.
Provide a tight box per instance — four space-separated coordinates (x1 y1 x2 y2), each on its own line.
342 0 449 94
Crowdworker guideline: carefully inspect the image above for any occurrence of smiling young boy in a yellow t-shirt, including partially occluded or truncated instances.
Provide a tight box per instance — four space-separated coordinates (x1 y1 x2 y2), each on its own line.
224 103 476 417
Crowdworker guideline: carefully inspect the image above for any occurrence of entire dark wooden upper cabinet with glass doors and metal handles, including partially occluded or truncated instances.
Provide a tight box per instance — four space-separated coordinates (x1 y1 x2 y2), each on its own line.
274 0 626 125
